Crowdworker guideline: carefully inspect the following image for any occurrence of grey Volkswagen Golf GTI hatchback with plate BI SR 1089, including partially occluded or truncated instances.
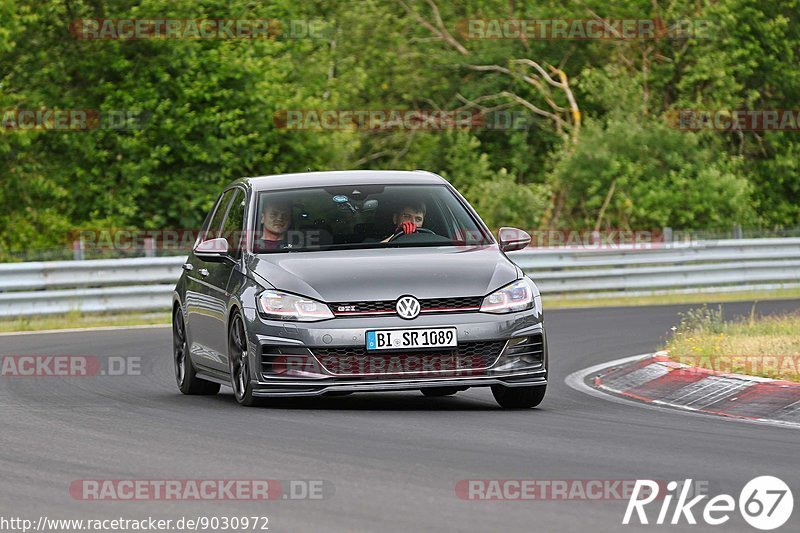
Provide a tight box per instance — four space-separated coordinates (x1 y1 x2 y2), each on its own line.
172 171 548 408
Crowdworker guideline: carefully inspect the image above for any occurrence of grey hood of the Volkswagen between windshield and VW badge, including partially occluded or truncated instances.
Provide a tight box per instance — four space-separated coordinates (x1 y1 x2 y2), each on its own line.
249 245 517 302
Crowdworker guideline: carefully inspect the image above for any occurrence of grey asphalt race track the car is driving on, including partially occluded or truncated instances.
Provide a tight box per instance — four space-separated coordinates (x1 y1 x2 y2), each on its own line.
0 301 800 532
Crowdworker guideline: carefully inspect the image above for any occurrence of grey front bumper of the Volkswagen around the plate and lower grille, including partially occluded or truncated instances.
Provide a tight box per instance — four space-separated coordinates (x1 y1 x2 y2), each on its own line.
244 309 548 397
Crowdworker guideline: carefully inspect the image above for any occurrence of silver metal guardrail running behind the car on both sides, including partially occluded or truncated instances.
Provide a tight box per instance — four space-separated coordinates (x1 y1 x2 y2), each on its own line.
0 238 800 317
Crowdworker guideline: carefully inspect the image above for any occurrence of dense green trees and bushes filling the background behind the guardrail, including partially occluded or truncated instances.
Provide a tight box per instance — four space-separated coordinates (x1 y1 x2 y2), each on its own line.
0 0 800 261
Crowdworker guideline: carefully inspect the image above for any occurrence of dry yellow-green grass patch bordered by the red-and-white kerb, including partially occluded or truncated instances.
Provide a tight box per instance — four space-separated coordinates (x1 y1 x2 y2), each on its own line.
664 305 800 382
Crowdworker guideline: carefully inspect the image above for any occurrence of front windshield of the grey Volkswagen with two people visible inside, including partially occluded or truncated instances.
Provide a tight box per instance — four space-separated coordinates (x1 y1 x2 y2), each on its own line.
253 185 492 254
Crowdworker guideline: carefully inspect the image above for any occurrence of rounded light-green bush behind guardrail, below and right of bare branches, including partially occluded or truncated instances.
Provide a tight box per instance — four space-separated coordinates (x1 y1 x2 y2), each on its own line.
551 113 751 230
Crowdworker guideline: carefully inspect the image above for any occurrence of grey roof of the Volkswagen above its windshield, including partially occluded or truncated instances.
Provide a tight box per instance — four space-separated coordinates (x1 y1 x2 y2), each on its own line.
241 170 447 191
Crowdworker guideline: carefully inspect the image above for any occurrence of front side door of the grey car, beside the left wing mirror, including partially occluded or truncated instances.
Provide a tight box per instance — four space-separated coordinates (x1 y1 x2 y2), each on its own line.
185 188 240 372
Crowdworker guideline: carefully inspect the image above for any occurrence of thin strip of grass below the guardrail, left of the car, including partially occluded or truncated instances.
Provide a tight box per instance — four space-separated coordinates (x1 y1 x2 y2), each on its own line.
0 311 170 332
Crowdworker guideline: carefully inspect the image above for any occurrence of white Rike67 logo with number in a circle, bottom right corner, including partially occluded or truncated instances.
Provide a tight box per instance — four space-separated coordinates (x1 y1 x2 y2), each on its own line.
622 476 794 531
